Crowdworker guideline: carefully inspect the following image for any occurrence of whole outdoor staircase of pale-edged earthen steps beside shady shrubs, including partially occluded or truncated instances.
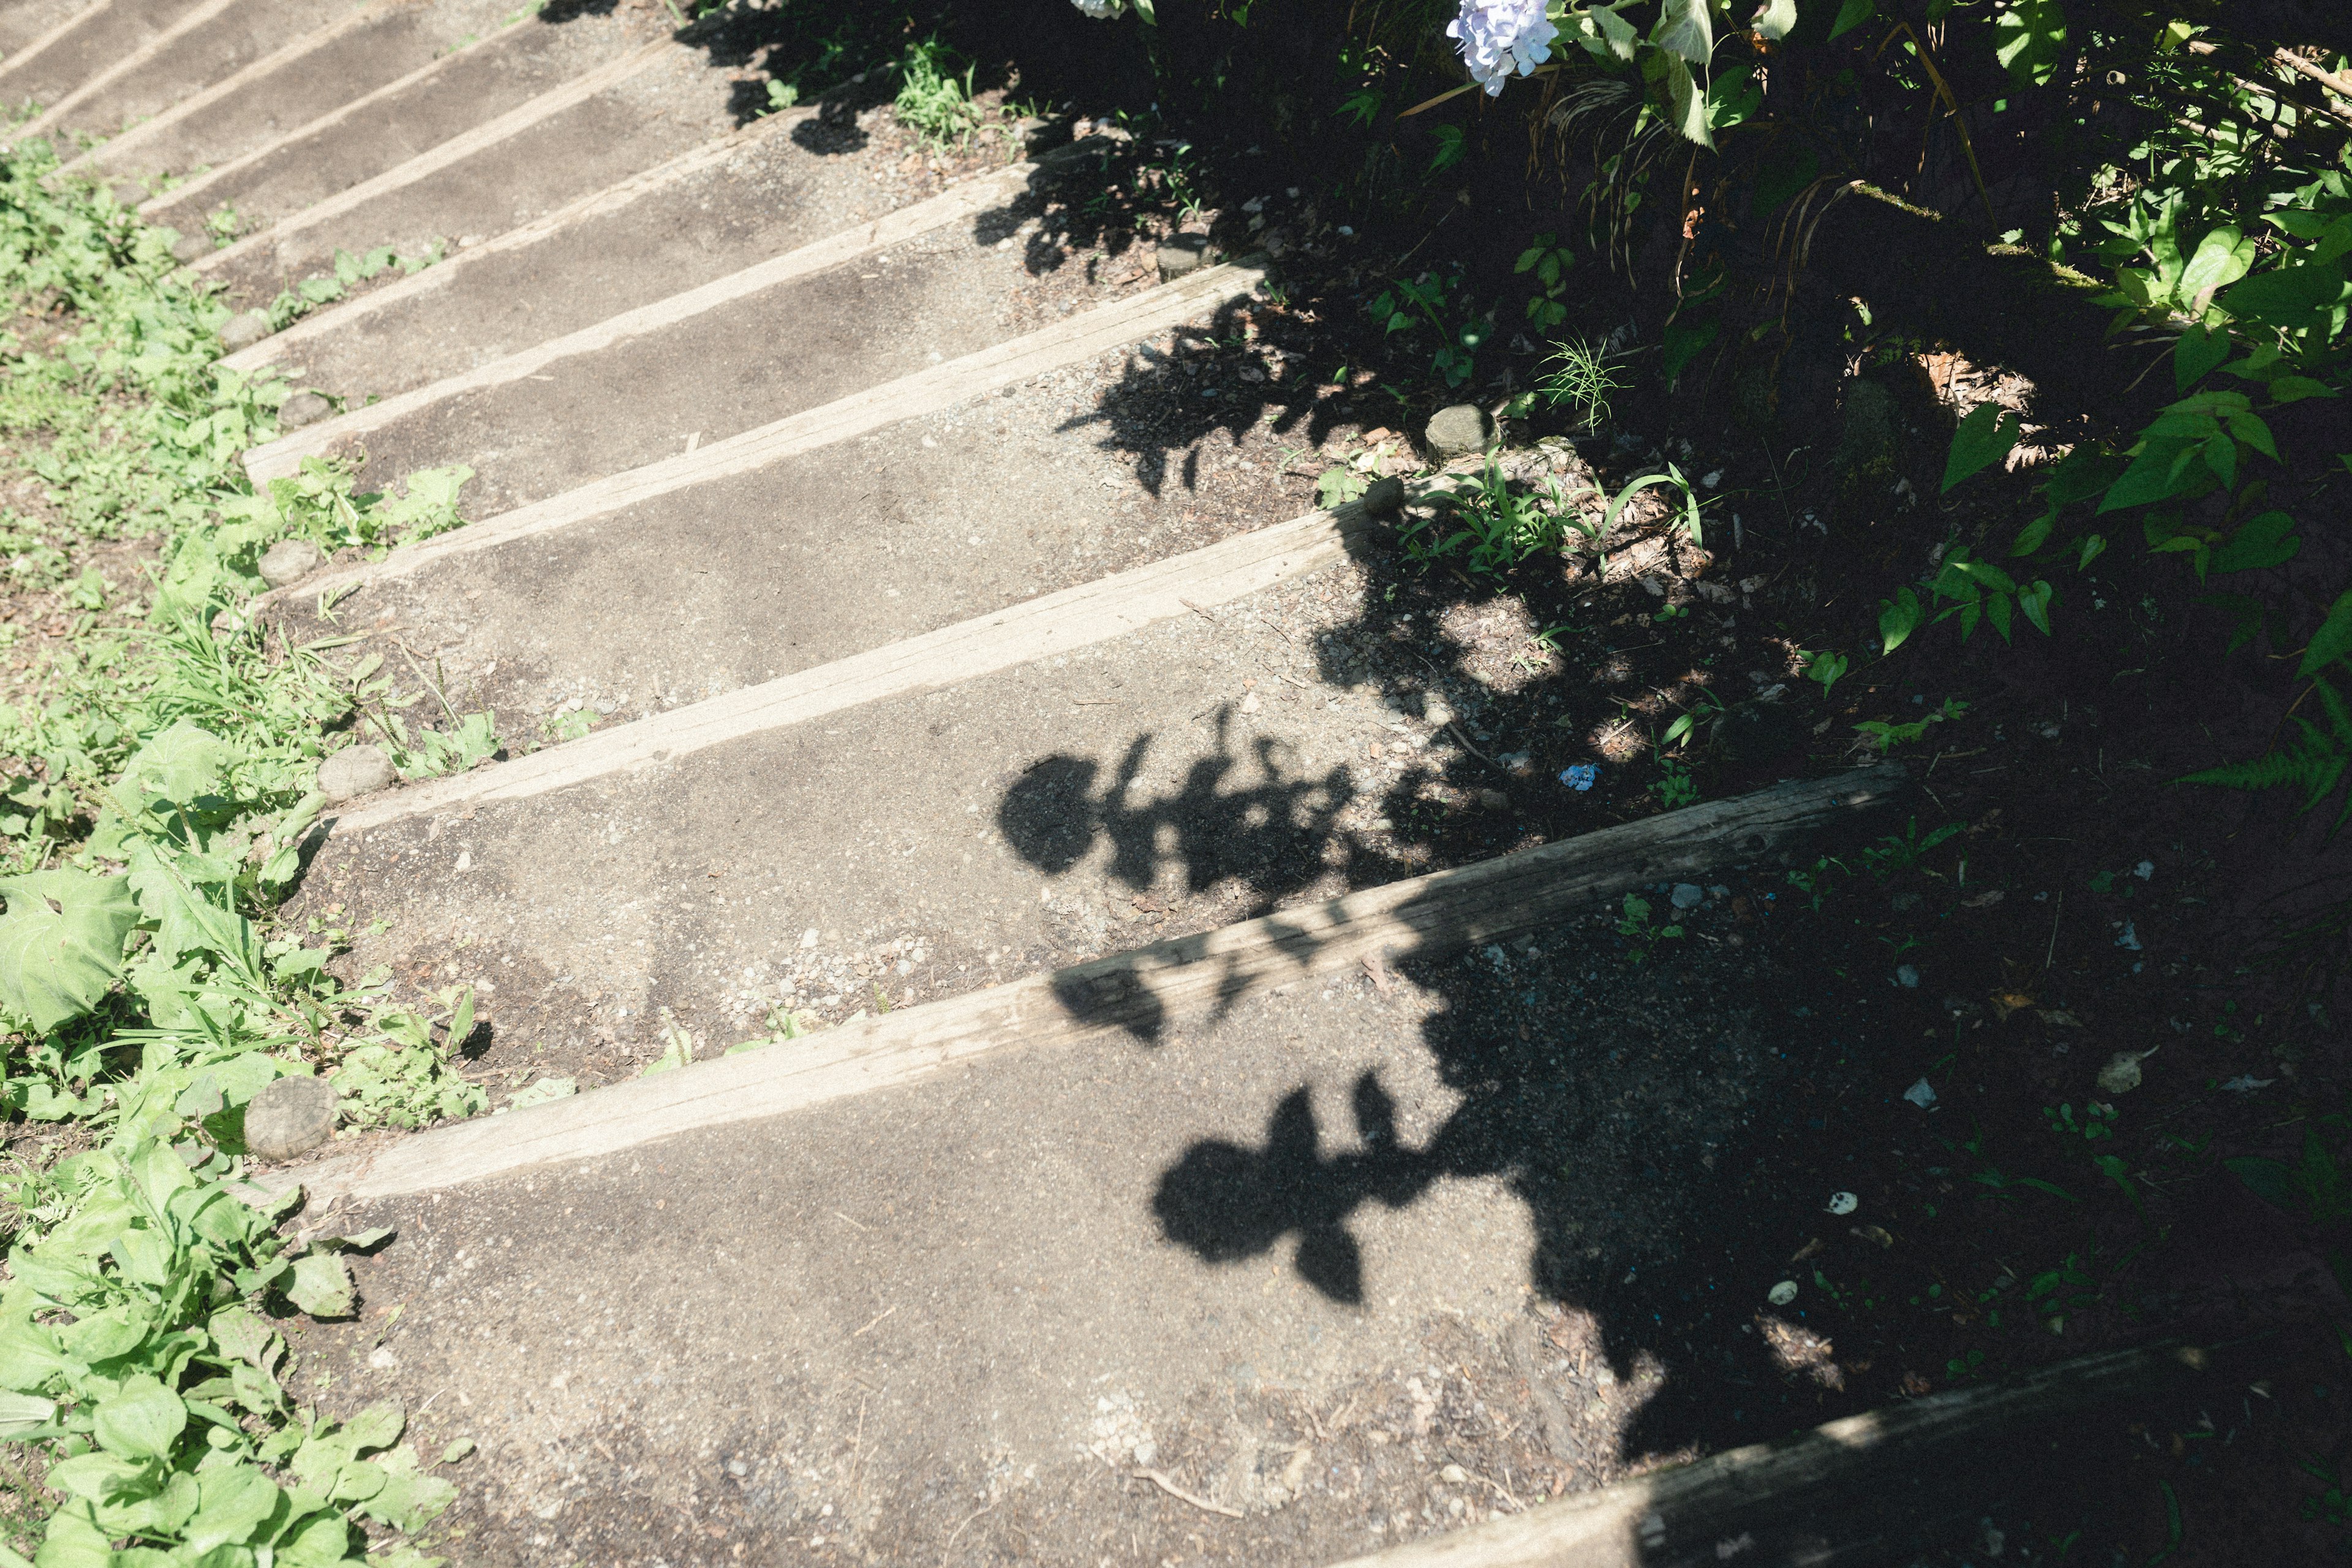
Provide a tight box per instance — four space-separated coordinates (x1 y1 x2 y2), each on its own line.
0 0 1898 1566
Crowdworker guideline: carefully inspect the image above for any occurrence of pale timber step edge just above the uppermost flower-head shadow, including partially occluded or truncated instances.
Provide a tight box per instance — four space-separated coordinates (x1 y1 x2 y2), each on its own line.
327 503 1366 839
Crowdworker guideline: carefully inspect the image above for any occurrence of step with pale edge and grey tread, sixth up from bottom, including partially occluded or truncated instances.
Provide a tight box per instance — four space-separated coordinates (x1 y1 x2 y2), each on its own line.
226 106 1011 404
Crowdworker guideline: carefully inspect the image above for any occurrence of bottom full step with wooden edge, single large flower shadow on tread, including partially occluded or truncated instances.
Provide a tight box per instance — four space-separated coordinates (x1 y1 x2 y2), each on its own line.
270 780 1896 1563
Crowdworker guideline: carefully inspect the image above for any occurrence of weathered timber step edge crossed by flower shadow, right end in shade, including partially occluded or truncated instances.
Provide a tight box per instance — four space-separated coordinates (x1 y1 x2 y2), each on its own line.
261 764 1907 1213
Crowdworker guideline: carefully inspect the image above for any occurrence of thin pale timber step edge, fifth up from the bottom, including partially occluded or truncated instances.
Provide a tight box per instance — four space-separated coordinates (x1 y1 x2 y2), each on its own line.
241 150 1037 463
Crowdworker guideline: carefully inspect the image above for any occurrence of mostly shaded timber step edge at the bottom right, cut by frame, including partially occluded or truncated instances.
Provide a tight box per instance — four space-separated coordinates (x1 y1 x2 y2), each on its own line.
1333 1344 2206 1568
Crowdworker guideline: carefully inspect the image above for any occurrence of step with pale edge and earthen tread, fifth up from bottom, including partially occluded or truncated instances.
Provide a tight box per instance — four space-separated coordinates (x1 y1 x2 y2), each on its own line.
247 151 1120 513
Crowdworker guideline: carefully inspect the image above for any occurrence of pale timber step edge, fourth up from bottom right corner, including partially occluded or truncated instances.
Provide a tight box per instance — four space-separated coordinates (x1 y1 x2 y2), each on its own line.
252 263 1265 611
